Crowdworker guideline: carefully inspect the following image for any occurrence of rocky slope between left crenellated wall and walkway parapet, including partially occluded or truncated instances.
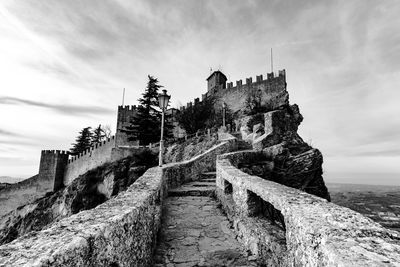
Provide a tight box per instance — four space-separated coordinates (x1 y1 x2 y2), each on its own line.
0 151 157 244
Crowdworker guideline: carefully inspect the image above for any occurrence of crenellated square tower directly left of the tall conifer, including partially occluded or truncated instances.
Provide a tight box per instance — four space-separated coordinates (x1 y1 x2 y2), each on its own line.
115 106 137 147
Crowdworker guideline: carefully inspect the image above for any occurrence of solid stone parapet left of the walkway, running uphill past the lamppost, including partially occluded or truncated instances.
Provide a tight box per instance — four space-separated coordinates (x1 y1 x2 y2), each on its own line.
0 137 235 267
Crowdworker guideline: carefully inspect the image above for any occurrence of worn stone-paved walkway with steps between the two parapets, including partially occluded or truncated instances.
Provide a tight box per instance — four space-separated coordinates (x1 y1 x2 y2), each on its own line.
154 173 257 267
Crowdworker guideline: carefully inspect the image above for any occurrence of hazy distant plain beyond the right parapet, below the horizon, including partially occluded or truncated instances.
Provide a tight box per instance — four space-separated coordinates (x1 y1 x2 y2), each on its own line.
327 183 400 232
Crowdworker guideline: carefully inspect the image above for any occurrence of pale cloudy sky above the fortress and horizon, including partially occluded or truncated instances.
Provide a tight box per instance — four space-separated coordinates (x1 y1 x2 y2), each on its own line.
0 0 400 185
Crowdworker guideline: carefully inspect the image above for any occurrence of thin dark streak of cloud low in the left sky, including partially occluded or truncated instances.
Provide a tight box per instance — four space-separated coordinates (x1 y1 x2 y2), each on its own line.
0 97 114 116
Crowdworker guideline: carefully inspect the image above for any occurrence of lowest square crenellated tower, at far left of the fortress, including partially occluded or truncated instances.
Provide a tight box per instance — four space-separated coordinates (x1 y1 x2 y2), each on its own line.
38 150 69 192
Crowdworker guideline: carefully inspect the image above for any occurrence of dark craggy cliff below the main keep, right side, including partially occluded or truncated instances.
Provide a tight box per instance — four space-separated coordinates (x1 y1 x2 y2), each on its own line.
238 105 330 200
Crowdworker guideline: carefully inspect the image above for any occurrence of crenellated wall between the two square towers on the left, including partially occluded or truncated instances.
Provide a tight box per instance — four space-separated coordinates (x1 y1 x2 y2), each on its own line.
64 136 115 185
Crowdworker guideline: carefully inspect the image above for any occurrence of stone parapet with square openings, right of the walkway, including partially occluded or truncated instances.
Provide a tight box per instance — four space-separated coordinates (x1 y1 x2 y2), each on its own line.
217 152 400 266
